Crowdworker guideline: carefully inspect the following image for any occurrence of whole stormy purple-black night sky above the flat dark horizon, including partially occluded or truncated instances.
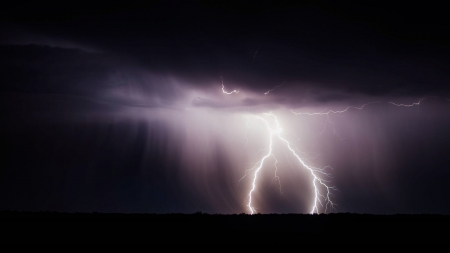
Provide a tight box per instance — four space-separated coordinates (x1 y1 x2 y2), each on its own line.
0 0 450 214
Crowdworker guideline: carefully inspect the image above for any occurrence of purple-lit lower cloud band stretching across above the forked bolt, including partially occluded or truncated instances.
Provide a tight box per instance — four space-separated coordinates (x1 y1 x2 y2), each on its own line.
0 45 449 115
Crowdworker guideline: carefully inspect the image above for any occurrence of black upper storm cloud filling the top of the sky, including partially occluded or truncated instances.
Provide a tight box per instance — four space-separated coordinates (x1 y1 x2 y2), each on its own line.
3 1 450 102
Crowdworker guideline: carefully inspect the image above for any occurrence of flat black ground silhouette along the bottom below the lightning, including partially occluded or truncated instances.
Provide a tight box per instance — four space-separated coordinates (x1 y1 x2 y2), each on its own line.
0 211 450 244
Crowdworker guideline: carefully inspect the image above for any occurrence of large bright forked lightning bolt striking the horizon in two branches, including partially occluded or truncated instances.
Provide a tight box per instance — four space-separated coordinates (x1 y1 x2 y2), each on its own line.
244 113 336 214
